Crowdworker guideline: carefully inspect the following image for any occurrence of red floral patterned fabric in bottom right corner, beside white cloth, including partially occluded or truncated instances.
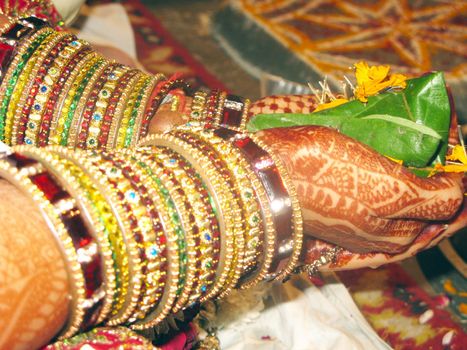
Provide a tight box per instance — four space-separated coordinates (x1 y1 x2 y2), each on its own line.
339 264 467 350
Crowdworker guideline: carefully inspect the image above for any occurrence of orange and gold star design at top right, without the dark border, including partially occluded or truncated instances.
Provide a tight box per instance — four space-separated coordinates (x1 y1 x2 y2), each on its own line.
239 0 467 82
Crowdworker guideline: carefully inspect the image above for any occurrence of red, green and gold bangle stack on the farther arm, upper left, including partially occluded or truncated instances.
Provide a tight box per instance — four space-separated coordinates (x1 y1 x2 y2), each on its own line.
0 17 194 149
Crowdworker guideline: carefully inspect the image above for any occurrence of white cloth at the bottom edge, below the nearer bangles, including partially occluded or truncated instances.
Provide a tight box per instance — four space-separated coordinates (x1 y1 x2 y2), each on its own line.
217 276 390 350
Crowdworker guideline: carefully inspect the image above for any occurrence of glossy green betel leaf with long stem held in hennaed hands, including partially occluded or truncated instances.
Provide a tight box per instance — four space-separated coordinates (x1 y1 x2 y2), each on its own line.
248 72 451 168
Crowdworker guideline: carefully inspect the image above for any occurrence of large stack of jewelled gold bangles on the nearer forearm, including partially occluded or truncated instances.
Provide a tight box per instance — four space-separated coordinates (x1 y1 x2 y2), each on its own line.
0 122 302 338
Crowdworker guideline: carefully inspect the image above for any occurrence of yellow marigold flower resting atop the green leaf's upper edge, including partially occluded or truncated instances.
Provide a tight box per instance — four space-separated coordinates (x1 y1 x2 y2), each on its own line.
355 61 407 102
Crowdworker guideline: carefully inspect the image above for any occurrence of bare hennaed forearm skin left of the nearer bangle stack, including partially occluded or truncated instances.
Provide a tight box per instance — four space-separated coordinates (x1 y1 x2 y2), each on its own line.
0 180 70 349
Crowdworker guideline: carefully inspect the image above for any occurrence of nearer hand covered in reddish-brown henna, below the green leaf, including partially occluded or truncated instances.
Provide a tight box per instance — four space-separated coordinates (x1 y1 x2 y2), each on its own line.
257 126 463 253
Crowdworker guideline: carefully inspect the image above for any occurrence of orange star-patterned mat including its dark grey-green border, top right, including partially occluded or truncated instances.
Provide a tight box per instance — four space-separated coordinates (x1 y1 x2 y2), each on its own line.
214 0 467 120
